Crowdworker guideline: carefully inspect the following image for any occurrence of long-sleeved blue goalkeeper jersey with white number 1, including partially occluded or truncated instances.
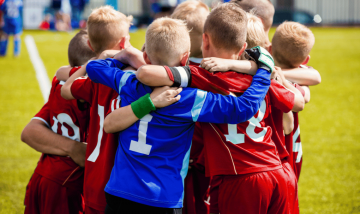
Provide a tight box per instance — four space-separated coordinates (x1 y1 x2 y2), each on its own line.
86 59 270 208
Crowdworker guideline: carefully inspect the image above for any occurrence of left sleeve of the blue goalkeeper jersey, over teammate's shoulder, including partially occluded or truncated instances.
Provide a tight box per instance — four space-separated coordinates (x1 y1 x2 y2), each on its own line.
86 58 126 91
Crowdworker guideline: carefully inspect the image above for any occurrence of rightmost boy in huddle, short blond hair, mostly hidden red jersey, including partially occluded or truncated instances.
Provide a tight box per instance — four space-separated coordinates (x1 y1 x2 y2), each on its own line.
270 22 315 179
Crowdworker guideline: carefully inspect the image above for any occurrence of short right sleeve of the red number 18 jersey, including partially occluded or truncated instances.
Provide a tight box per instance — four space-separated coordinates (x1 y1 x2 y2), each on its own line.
269 80 295 113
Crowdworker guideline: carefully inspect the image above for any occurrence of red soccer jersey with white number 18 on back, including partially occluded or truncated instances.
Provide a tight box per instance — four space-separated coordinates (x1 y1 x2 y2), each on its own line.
184 66 294 176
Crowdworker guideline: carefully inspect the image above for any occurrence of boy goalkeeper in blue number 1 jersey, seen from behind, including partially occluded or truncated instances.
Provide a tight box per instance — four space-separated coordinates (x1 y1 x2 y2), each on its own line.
86 18 273 213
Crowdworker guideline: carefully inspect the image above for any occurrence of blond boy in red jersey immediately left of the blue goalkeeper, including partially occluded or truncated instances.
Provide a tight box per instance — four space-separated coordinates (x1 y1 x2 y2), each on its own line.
57 6 132 213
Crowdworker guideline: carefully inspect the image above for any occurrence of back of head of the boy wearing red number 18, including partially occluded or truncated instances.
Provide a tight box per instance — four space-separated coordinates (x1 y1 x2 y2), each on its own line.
204 3 247 51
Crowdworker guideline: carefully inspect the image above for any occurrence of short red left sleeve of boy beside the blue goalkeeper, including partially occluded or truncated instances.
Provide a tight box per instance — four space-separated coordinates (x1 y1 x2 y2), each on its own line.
71 77 95 103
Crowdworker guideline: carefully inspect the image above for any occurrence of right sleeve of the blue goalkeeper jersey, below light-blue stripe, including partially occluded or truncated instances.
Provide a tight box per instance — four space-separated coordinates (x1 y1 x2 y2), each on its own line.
191 69 270 124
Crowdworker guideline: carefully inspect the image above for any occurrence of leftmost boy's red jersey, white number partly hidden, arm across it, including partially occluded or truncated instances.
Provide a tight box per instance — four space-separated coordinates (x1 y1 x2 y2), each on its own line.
34 67 89 190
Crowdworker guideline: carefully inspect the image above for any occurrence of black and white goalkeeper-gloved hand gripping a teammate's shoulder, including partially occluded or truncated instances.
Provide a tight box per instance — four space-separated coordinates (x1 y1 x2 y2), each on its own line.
245 46 275 73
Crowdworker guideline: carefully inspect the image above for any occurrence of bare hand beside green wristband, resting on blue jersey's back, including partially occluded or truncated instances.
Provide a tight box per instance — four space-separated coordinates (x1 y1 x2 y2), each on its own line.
150 86 182 108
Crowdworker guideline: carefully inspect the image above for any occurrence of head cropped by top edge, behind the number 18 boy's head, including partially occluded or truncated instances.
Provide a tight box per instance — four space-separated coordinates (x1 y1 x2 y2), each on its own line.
230 0 275 32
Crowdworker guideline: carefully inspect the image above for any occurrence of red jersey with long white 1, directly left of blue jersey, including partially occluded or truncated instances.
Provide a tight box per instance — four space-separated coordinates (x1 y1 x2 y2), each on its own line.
71 77 120 211
